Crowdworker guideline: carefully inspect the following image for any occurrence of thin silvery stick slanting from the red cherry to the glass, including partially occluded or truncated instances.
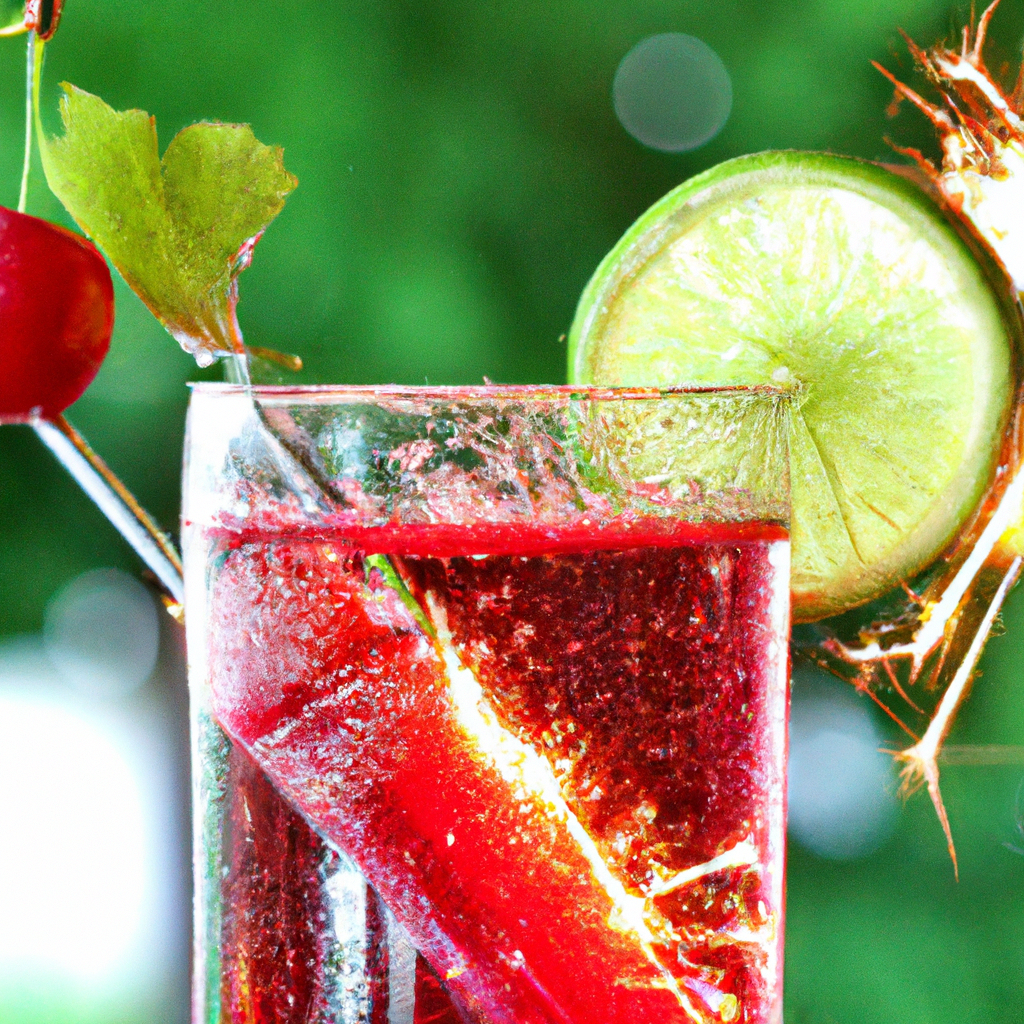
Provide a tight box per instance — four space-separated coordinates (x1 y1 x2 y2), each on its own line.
33 416 184 614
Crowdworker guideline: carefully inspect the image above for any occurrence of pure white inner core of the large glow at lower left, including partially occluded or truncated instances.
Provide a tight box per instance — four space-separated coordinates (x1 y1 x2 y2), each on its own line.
0 689 150 984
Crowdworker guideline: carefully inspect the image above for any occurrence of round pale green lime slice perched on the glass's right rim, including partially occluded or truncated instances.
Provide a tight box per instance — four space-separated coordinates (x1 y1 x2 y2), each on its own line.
569 153 1017 621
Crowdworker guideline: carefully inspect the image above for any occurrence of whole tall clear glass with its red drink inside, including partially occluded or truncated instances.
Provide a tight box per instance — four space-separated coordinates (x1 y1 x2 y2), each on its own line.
183 385 788 1024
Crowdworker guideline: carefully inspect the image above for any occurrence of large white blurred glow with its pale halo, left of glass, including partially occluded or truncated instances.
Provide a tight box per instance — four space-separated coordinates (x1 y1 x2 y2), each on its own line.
0 589 184 1003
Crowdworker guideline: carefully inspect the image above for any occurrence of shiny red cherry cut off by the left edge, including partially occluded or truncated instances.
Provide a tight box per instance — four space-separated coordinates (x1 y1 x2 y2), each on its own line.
0 207 114 423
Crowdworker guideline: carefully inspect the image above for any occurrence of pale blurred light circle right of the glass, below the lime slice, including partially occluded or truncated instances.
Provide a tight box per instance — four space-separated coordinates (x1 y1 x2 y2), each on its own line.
790 669 898 860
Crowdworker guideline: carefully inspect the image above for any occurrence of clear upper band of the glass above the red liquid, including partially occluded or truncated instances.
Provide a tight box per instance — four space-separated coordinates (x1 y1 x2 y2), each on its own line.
184 382 794 526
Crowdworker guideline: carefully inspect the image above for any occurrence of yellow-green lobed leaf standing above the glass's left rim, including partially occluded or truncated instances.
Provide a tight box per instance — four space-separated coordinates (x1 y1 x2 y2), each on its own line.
37 83 298 366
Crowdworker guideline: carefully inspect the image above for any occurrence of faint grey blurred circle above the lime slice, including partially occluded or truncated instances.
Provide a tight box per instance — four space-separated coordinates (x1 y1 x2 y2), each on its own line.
611 32 732 153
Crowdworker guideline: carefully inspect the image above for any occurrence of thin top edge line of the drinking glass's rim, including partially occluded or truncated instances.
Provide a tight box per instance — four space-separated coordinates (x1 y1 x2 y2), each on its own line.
187 381 794 401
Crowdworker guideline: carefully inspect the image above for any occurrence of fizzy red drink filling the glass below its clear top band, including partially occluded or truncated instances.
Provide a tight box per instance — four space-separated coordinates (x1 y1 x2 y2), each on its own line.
195 517 788 1024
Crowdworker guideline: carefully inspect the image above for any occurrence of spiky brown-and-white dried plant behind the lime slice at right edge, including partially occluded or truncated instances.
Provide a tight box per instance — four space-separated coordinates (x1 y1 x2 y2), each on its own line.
811 0 1024 869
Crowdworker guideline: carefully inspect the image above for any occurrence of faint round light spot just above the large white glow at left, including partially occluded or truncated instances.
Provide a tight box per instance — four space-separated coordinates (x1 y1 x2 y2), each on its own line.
44 569 160 696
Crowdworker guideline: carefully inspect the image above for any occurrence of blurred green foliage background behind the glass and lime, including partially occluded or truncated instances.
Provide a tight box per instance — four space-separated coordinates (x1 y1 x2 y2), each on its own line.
0 0 1024 1024
